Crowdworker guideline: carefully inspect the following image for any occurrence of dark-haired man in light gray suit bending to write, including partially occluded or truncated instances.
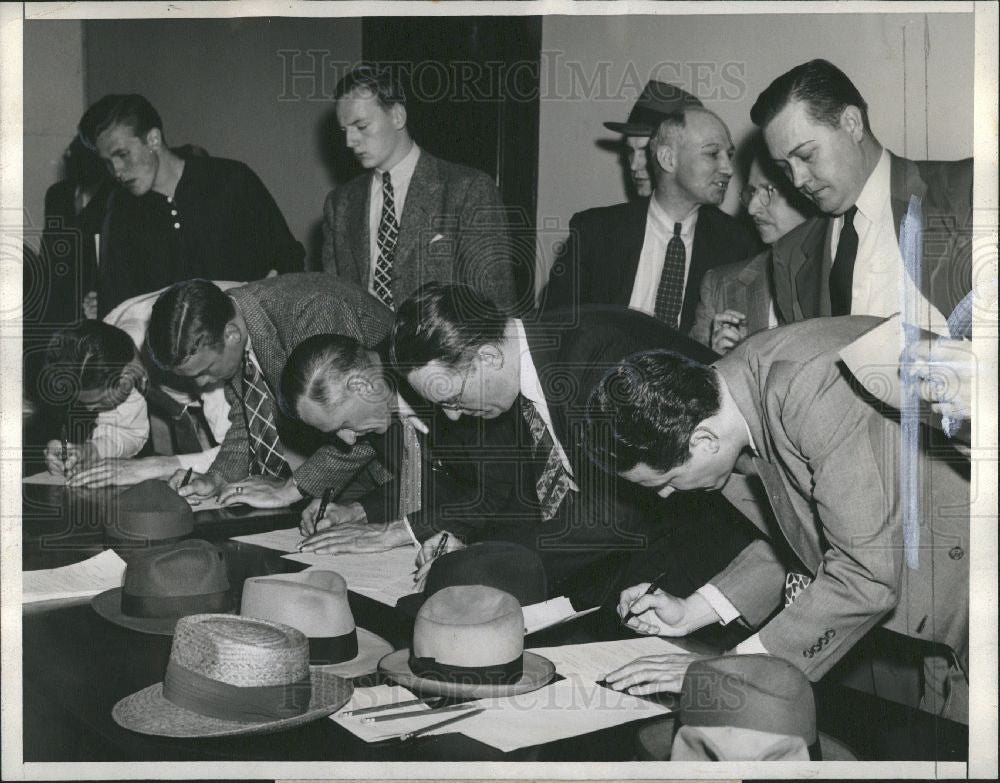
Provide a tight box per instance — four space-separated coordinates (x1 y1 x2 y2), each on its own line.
589 316 969 722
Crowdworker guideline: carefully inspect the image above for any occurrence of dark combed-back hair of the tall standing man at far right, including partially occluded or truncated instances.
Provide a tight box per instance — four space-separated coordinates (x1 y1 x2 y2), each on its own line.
750 60 871 133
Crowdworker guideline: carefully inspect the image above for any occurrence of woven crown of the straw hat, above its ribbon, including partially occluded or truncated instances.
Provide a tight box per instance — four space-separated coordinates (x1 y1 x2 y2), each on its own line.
170 614 309 688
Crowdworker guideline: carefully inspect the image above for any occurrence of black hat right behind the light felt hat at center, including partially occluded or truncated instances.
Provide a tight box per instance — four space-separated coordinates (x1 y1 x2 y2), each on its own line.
396 541 549 617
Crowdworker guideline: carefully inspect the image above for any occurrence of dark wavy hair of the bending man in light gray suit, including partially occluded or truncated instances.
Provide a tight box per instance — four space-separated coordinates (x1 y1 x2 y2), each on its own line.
587 350 721 473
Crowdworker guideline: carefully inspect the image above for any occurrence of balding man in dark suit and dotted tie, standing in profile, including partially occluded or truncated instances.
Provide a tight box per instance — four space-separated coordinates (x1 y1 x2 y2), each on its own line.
543 102 758 333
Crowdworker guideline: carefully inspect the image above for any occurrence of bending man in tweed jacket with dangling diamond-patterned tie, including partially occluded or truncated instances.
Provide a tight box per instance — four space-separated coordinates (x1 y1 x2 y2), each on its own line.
147 273 391 507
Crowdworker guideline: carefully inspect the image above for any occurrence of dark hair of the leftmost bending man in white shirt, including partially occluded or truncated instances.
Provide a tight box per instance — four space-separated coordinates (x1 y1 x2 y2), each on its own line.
40 320 136 402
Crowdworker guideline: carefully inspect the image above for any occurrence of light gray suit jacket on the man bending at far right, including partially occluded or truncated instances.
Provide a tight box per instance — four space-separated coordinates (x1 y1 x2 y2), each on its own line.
711 316 969 681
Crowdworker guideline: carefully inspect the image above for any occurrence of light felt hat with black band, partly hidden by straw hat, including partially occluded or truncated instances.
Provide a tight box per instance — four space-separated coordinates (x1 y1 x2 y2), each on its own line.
240 571 392 677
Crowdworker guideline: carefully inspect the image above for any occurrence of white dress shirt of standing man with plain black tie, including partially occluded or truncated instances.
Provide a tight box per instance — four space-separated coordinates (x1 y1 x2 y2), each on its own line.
830 149 948 335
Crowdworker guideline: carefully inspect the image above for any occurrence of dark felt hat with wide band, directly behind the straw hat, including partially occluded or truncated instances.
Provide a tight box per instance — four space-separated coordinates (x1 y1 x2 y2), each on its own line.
90 539 234 636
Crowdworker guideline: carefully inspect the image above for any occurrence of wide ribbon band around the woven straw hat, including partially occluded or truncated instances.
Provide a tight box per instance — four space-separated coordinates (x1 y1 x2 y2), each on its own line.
163 661 312 723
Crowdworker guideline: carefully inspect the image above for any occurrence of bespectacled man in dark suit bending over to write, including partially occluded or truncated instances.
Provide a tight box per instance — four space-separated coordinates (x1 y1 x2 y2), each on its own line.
391 284 752 605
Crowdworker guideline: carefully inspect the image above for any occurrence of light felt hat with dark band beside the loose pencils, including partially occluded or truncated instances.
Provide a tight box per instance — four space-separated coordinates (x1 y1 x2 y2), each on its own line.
379 585 556 698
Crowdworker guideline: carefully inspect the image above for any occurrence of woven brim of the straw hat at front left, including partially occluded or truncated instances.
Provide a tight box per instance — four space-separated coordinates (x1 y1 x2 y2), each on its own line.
111 666 354 737
